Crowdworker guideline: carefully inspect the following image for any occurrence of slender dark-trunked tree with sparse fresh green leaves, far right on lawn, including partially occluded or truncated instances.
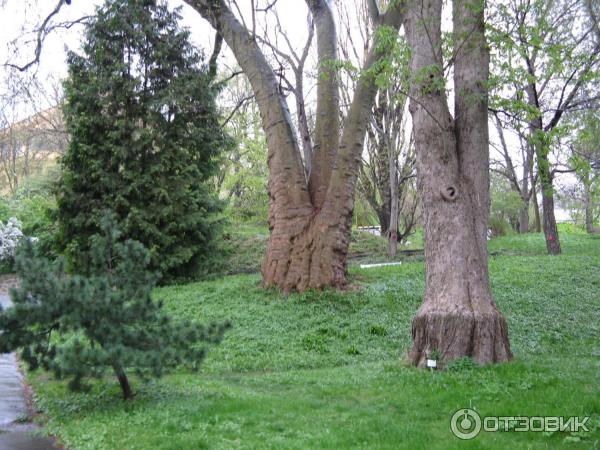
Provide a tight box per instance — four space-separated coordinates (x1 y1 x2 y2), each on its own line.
490 0 600 254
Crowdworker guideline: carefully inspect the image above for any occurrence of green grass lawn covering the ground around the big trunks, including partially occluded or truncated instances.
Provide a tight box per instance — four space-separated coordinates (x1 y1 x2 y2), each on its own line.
30 233 600 450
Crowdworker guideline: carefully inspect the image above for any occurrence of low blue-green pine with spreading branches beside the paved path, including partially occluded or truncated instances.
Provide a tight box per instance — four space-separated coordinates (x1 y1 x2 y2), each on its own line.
0 214 229 399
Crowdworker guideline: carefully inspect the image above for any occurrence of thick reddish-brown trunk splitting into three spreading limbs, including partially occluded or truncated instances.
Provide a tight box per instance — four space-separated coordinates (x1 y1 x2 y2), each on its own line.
185 0 403 292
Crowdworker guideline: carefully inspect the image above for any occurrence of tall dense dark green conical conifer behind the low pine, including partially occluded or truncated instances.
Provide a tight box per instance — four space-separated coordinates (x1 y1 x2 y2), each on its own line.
57 0 232 279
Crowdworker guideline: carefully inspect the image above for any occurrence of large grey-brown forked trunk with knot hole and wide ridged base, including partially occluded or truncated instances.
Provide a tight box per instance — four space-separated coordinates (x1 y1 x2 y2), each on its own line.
405 0 511 366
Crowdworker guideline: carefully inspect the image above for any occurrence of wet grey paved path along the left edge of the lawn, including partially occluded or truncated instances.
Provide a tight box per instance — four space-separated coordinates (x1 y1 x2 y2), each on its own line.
0 284 55 450
